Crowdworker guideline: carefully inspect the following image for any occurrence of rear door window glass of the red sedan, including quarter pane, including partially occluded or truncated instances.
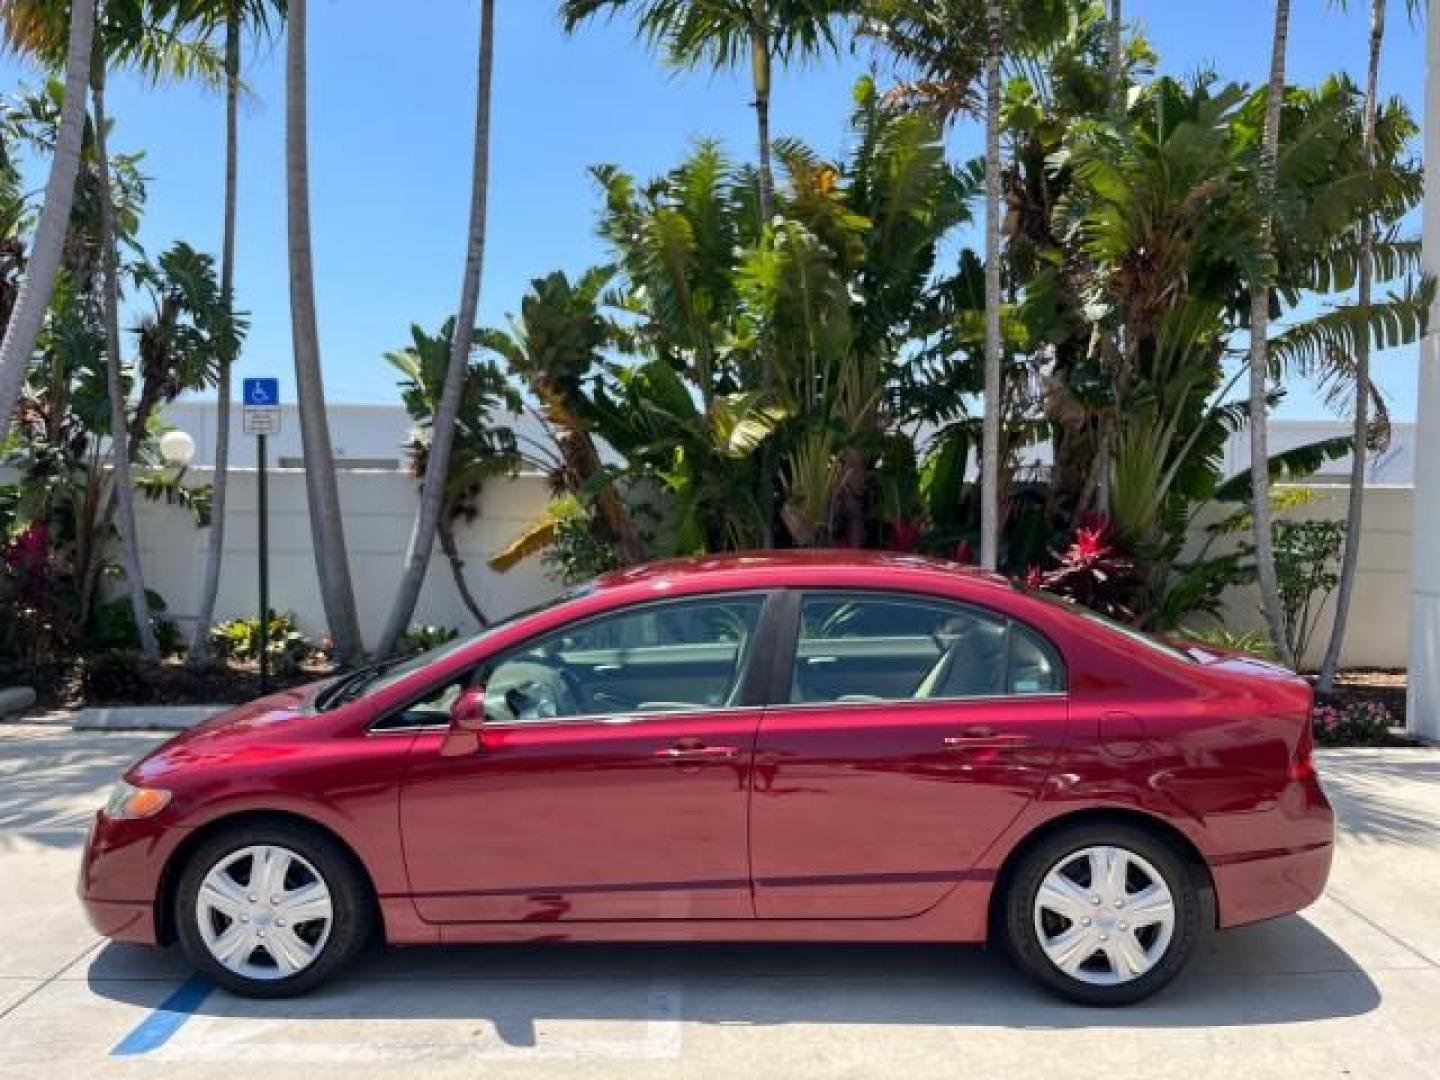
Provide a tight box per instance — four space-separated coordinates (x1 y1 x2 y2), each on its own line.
791 593 1064 703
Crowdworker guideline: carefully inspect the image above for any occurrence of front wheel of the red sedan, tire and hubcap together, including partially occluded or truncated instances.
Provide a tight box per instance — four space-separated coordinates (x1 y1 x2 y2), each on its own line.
174 822 374 998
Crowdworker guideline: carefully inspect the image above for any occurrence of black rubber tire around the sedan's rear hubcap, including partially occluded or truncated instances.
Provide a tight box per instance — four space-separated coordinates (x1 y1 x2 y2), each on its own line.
1002 822 1201 1007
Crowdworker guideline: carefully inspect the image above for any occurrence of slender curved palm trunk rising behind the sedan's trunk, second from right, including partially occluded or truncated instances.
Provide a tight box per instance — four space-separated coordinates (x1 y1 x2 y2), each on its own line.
1250 0 1300 667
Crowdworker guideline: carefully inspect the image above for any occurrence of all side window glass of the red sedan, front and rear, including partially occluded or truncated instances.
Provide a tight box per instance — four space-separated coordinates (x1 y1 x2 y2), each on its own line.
384 593 1064 727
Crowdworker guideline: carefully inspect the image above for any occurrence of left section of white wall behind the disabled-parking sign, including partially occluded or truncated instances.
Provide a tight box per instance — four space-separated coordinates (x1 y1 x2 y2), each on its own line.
137 469 559 644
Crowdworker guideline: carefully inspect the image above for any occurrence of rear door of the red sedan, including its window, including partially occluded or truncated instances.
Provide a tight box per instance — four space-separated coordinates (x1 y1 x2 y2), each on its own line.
750 592 1067 919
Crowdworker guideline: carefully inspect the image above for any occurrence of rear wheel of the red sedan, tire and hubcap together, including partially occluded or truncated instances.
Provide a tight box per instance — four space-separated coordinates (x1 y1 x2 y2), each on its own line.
1004 824 1200 1005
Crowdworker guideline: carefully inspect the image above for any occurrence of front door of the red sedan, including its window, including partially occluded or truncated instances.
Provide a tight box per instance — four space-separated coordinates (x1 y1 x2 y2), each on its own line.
400 593 765 922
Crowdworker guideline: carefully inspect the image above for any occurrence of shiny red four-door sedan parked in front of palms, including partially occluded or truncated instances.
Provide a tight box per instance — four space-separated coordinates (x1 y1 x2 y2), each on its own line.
81 553 1333 1005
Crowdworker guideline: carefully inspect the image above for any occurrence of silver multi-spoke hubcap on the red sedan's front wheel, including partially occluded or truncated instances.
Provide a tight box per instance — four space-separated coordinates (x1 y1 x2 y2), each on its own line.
194 844 334 979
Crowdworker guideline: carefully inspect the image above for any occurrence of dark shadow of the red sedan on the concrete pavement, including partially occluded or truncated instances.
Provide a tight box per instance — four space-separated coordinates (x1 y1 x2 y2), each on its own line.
88 916 1381 1048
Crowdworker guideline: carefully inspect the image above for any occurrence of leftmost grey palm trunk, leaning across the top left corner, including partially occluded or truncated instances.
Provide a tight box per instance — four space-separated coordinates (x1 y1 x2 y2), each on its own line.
0 3 95 438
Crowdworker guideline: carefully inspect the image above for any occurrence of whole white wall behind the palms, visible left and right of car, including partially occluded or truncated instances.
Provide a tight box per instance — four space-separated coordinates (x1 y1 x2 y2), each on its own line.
28 457 1413 667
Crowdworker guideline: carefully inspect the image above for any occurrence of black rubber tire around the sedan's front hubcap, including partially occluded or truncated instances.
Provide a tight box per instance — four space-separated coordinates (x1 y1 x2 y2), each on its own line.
173 821 376 998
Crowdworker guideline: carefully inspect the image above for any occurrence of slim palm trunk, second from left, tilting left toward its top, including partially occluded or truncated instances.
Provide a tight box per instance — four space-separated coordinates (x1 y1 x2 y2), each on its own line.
90 46 160 661
